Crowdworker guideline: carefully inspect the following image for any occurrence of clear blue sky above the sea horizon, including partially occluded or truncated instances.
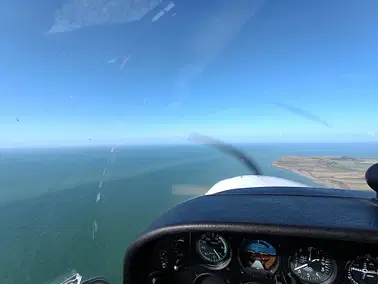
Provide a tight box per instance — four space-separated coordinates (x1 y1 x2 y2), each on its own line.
0 0 378 147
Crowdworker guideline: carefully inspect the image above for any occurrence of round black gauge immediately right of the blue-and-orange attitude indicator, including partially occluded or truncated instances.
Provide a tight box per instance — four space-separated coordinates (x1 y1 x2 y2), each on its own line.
289 247 337 284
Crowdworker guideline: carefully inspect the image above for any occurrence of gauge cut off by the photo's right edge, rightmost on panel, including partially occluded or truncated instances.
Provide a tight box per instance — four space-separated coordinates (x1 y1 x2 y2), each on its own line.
347 255 378 284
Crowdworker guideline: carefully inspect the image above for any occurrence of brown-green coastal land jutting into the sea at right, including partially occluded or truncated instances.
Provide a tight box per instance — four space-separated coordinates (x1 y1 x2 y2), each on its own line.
272 156 378 190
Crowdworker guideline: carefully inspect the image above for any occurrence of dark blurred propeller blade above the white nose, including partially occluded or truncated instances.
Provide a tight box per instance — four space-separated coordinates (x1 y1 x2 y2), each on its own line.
188 133 262 176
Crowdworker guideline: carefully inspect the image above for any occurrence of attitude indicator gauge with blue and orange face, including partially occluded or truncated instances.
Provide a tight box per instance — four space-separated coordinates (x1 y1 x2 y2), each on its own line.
239 240 279 274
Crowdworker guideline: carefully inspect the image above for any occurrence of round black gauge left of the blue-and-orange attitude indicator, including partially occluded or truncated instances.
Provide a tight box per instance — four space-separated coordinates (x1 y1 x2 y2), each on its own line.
197 233 230 265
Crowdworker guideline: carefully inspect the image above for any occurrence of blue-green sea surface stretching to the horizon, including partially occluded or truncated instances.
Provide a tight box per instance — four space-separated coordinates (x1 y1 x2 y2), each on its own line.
0 144 378 284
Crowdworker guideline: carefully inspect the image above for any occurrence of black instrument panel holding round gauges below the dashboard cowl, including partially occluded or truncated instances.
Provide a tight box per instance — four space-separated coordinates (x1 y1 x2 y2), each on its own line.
148 232 378 284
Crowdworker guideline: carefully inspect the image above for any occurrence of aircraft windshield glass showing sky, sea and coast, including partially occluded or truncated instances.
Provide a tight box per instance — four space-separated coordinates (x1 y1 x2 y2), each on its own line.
0 0 378 283
